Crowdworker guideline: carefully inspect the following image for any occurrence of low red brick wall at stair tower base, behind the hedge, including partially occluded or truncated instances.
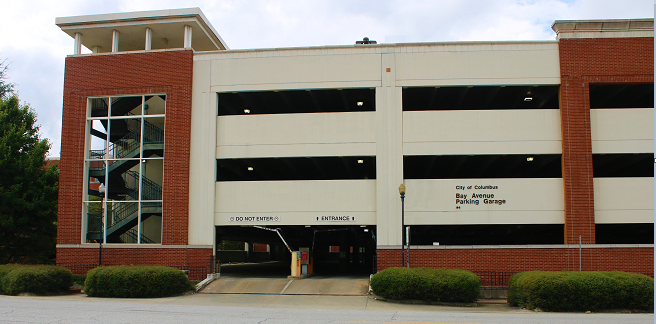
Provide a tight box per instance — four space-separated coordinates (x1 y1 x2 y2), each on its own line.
57 245 212 280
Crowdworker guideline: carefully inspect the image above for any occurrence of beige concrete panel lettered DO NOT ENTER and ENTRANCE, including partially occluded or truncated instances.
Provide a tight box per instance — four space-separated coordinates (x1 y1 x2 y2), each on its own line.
215 180 376 225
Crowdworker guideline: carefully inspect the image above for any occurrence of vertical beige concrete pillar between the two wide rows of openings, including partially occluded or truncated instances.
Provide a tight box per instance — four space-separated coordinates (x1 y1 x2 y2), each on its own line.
376 54 403 245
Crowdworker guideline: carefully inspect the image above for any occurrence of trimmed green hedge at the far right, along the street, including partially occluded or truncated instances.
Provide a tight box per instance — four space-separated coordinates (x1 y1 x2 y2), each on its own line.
508 271 654 311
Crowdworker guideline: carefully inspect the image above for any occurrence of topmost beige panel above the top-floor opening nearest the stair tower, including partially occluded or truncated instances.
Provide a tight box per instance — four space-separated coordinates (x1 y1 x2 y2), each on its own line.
212 53 380 88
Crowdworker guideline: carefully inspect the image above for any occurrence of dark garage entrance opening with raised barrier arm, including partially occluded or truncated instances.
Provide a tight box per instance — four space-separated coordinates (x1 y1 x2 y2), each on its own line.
216 225 376 277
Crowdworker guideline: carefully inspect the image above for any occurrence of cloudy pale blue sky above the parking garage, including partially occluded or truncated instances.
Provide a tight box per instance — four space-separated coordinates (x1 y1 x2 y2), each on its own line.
0 0 655 157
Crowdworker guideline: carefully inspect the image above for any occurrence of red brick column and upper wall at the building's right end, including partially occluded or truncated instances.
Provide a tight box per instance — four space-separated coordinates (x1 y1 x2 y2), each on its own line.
558 38 654 244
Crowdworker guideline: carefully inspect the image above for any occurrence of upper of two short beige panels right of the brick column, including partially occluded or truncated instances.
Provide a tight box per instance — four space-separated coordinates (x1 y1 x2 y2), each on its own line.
590 108 654 153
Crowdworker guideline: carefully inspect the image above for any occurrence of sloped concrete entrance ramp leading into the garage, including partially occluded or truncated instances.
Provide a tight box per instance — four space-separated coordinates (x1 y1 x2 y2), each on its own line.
200 277 369 296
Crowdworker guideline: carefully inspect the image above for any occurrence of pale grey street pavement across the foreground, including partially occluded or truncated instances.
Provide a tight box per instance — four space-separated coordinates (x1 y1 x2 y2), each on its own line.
0 294 654 324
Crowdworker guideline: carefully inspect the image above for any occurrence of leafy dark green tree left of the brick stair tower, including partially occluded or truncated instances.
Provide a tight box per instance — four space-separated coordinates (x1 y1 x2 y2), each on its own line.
0 95 59 264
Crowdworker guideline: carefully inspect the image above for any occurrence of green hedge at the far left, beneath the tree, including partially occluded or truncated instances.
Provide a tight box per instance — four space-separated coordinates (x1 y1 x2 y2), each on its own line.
0 264 73 295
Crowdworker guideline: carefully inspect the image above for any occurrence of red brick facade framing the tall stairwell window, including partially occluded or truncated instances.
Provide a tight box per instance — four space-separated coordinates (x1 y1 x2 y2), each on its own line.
57 50 212 274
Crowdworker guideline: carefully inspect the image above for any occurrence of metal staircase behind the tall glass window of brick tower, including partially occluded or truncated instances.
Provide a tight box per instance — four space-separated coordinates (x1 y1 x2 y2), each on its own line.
87 97 164 243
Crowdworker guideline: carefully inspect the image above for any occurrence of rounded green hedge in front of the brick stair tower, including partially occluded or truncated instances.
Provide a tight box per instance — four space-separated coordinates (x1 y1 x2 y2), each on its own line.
84 266 194 298
